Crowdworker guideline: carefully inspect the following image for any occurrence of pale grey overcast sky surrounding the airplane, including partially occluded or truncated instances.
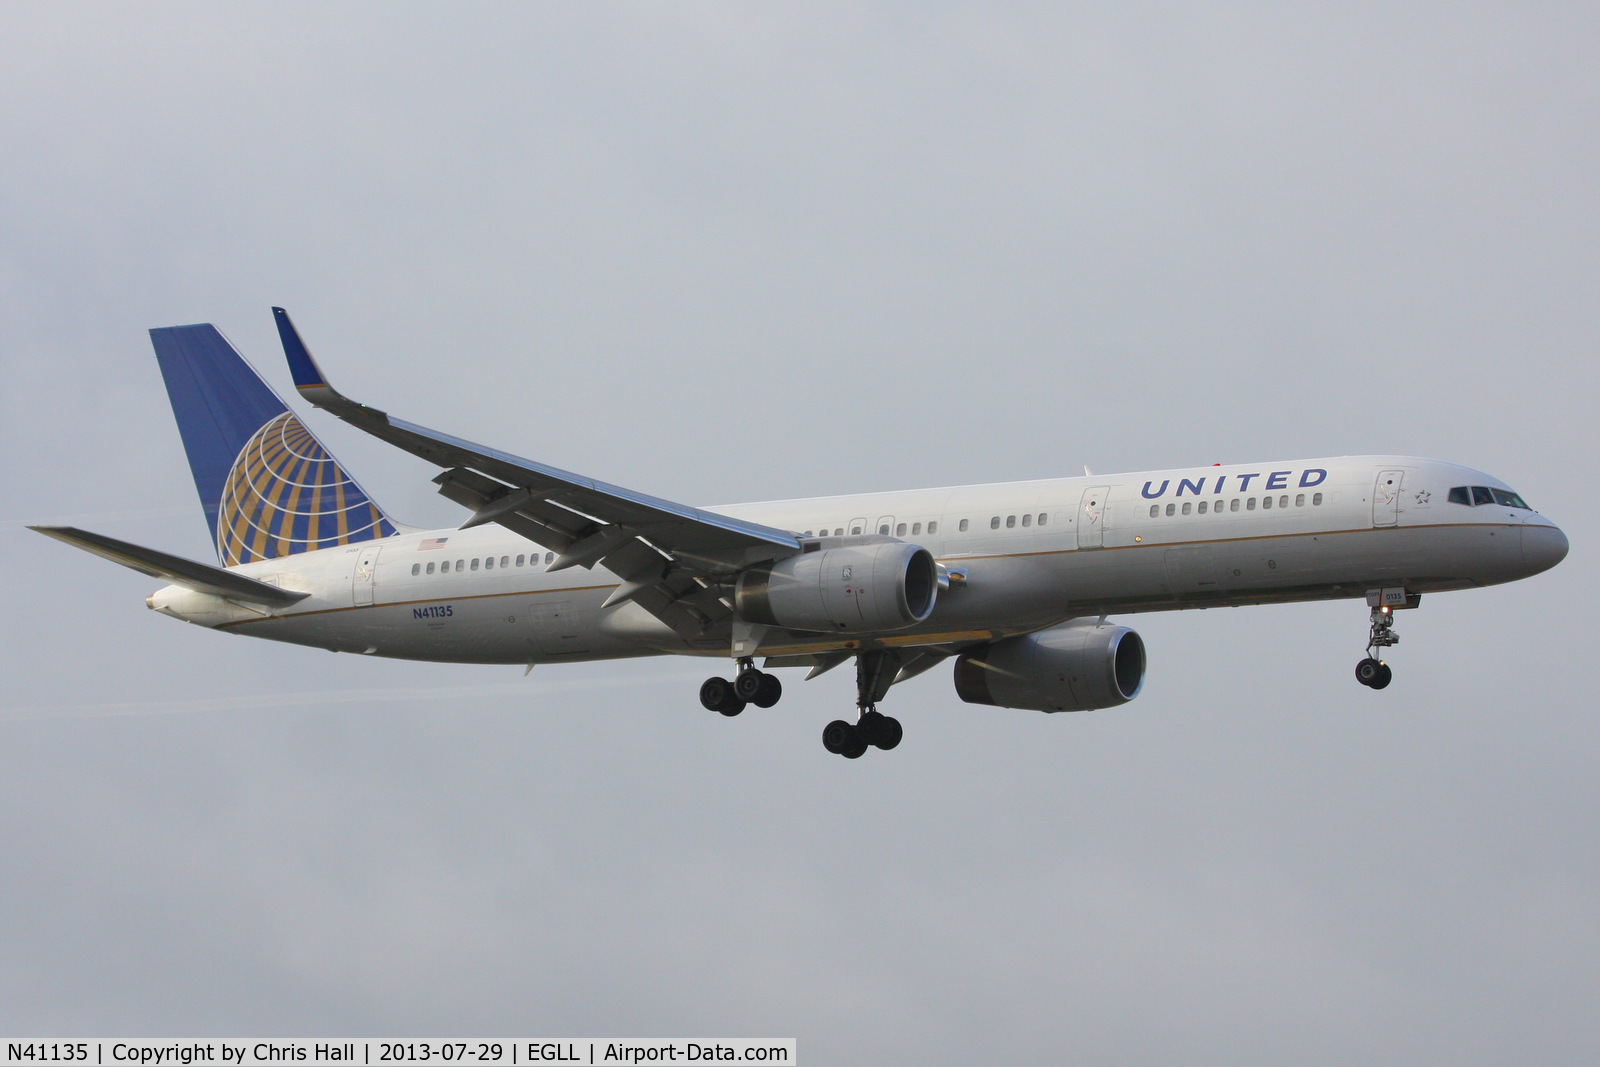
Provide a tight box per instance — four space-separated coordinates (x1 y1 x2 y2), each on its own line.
0 3 1600 1064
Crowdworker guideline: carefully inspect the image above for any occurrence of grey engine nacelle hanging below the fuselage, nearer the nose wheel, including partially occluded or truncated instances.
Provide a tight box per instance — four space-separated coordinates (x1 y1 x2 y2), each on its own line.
955 622 1144 712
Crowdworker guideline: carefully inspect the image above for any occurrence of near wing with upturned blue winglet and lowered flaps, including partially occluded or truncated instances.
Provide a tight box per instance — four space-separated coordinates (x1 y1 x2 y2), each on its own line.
272 307 800 640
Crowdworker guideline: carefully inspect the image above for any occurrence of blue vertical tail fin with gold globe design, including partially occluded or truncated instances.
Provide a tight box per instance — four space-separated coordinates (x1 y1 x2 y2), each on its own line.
150 323 395 566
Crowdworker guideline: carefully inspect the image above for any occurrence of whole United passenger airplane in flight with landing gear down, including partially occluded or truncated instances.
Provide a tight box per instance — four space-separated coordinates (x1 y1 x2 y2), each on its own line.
32 307 1568 758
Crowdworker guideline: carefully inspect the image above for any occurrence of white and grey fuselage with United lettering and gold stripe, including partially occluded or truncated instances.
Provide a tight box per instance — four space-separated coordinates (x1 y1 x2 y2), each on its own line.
149 456 1566 664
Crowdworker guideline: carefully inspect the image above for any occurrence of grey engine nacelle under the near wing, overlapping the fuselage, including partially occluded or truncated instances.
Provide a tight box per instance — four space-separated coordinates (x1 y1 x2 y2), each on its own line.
734 541 939 633
